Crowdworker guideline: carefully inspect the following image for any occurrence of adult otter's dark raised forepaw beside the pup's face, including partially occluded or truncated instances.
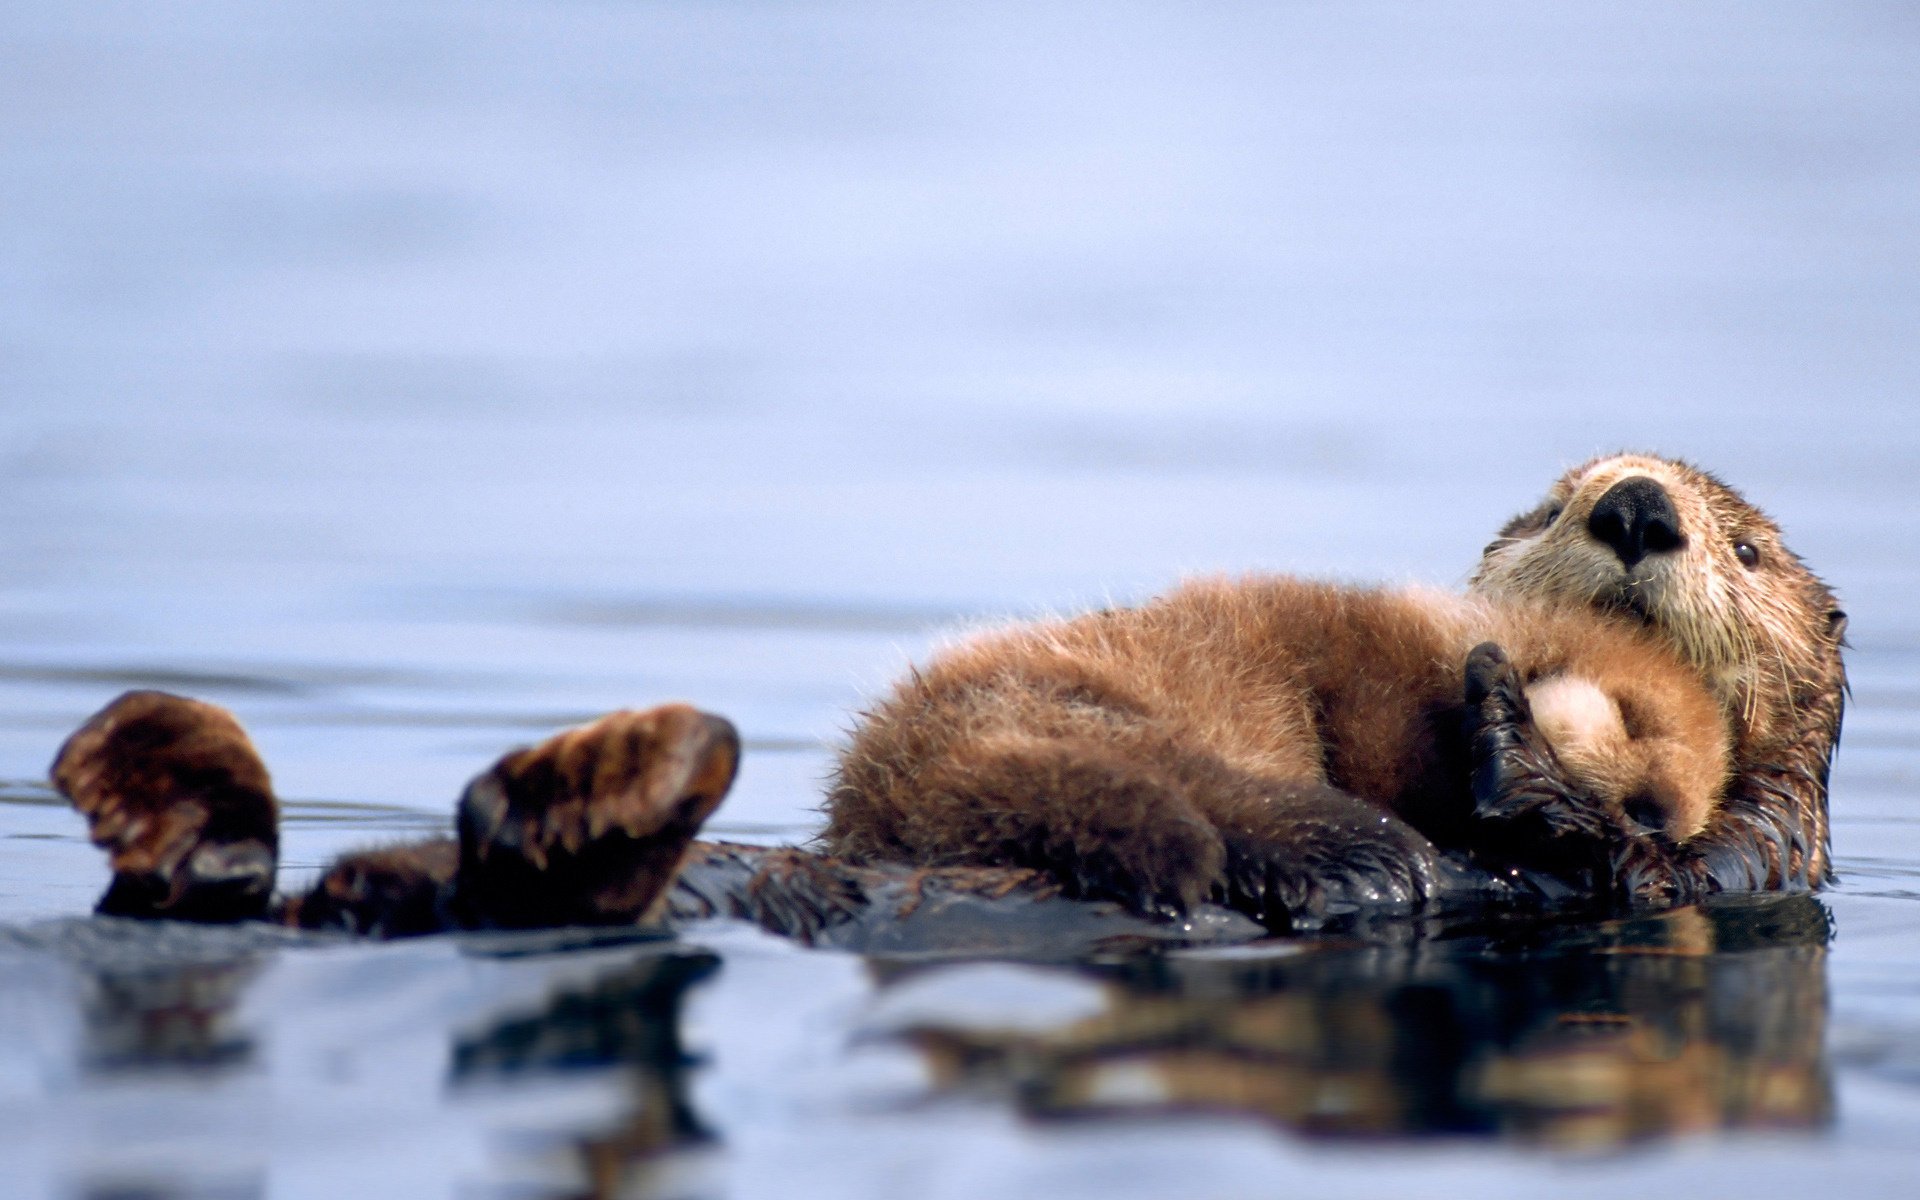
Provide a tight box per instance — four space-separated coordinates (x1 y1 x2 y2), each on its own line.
1465 641 1615 852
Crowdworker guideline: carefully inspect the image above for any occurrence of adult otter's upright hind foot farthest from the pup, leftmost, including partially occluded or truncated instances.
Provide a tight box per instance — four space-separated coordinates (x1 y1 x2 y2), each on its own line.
52 691 280 922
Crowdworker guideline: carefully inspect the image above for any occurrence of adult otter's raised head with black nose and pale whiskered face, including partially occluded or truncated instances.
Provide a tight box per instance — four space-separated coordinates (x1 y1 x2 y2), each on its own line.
1471 455 1847 749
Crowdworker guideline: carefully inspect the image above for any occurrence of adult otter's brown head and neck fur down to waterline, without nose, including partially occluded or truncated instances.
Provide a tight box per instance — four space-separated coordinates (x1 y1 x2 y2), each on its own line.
1471 455 1847 893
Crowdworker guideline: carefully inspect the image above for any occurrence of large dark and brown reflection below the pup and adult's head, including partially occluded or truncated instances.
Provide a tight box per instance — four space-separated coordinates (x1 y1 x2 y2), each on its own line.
876 895 1834 1148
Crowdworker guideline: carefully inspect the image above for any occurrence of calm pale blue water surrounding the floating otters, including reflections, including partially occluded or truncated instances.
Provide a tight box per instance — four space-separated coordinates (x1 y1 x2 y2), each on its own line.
0 0 1920 1196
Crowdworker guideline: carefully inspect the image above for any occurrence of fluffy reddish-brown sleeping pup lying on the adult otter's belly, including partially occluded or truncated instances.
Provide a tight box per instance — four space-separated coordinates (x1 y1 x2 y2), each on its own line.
822 578 1726 920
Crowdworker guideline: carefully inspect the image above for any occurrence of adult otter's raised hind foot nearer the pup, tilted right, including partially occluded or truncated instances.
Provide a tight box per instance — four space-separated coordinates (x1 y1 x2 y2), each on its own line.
455 705 739 927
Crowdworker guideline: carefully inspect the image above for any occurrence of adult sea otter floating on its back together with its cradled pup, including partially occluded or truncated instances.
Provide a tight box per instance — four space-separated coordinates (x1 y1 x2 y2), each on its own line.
54 457 1843 935
